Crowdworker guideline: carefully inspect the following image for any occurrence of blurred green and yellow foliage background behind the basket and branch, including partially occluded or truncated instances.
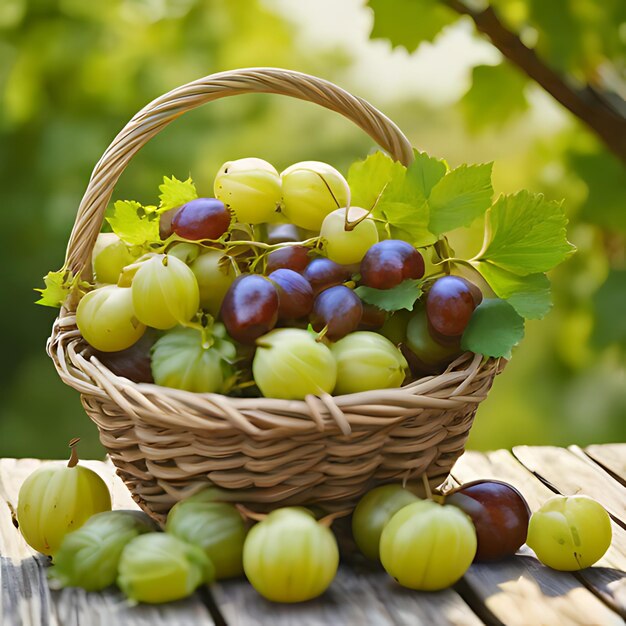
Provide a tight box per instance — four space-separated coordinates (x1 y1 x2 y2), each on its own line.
0 0 626 458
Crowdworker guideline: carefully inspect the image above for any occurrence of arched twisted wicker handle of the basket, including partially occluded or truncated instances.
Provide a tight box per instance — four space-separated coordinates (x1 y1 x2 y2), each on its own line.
65 68 413 273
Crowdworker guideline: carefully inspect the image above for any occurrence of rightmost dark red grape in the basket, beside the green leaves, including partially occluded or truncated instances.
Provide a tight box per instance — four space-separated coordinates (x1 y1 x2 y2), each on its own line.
426 276 476 337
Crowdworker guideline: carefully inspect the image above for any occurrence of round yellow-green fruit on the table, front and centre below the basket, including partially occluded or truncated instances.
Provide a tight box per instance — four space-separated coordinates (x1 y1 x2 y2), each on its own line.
243 508 339 602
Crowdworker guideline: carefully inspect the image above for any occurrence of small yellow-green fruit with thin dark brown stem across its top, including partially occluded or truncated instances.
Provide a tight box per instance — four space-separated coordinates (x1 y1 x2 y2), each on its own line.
320 207 378 265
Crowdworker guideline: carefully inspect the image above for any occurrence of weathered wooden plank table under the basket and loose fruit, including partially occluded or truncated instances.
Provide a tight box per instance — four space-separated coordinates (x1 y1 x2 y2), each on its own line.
0 444 626 626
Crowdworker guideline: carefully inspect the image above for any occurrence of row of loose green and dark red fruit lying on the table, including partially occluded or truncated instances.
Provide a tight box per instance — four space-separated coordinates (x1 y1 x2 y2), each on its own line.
18 442 611 603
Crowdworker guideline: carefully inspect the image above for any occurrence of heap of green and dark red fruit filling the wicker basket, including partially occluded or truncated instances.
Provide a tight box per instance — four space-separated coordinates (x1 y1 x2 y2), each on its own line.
76 158 482 399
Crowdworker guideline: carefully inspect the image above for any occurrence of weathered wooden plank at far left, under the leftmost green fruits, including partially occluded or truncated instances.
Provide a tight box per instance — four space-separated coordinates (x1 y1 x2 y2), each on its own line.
0 459 214 626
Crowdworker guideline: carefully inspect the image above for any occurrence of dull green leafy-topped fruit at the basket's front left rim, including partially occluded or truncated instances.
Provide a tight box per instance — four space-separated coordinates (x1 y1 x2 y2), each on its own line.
151 324 237 393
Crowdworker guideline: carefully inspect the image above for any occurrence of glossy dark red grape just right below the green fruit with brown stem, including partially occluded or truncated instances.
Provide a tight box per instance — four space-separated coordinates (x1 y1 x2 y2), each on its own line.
361 239 424 289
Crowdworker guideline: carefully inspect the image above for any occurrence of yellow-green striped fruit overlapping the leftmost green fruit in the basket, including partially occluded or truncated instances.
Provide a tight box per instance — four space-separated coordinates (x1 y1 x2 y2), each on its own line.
131 254 200 330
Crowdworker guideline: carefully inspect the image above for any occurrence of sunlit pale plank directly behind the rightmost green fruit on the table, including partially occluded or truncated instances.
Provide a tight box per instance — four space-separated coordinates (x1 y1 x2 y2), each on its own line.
513 446 626 525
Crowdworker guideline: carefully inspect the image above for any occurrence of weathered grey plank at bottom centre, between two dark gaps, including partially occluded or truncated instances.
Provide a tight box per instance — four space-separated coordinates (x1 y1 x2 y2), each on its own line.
213 565 483 626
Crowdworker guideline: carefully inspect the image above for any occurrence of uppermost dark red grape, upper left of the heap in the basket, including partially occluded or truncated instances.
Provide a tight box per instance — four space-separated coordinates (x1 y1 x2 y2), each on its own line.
172 198 232 241
